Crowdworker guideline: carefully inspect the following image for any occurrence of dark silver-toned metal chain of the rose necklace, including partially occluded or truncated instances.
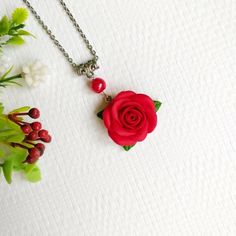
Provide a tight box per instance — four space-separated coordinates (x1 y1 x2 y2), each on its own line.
22 0 98 70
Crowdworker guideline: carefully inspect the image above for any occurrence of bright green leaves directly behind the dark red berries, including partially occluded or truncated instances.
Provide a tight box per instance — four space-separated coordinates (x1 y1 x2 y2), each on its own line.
0 103 41 184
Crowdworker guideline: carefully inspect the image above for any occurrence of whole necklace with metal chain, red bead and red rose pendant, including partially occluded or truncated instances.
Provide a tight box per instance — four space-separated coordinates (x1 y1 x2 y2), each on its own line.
22 0 161 151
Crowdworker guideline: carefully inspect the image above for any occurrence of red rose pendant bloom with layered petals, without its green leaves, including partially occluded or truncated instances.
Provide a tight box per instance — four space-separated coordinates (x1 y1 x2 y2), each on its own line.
102 91 157 146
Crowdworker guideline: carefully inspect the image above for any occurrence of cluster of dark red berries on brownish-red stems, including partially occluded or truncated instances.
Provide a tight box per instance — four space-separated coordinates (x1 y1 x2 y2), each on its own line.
8 108 52 164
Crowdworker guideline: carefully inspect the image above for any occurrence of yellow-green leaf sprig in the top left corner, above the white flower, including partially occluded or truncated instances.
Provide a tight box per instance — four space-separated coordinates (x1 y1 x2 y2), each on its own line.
0 8 33 51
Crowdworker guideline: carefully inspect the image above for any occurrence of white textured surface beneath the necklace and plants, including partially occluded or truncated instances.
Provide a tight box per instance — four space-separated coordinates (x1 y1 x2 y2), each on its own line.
0 0 236 236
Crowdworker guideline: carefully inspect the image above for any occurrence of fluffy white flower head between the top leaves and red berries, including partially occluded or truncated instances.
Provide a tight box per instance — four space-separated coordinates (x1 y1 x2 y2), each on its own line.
22 61 49 87
